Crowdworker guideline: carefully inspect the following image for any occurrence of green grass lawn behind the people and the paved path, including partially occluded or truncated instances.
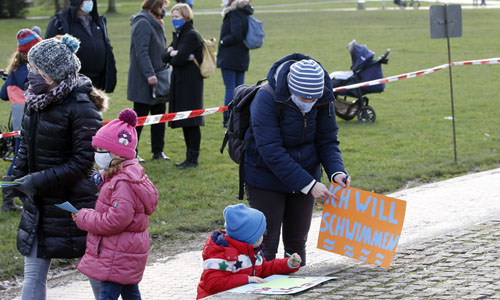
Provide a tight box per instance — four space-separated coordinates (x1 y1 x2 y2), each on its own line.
0 0 500 279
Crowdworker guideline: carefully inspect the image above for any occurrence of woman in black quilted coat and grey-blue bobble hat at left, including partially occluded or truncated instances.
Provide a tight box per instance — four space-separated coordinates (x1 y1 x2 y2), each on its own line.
12 35 108 300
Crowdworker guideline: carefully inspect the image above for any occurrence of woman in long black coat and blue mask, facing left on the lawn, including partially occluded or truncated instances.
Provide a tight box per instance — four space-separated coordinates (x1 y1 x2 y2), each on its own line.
163 3 204 169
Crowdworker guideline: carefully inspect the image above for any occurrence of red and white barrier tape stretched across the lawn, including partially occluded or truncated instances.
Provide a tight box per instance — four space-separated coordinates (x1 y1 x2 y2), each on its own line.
0 58 500 139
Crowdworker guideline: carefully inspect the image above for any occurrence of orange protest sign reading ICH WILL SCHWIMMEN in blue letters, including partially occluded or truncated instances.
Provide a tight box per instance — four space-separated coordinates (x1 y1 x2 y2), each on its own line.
317 183 406 268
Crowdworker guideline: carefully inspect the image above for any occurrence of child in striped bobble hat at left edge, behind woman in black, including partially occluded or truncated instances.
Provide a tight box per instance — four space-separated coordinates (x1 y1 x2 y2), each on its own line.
0 29 42 212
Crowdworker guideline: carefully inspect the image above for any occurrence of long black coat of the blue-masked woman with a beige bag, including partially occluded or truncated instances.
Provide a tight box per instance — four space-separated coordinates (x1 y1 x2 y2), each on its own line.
163 21 204 128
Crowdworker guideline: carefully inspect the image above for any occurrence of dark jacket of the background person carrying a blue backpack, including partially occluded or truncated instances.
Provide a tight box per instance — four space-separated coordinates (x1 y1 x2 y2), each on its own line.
217 0 253 72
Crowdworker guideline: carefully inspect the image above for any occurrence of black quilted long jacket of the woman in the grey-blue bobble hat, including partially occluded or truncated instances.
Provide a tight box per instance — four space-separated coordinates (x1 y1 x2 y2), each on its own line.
13 75 107 258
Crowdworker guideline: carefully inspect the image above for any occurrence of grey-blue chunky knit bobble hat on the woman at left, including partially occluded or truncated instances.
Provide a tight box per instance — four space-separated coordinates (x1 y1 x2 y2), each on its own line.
28 34 81 82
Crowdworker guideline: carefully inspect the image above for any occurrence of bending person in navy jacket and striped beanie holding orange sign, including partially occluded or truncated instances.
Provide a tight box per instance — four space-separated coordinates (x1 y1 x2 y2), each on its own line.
244 53 350 265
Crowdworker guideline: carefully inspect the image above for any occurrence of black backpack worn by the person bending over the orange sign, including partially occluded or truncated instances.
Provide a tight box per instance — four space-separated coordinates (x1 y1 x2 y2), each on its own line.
220 79 274 200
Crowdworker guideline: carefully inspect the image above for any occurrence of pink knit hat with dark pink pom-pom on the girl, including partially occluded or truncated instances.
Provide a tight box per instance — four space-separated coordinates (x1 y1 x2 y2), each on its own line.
92 108 137 159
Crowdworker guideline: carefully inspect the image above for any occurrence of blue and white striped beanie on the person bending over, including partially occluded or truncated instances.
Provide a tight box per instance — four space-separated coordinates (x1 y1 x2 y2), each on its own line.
287 59 325 99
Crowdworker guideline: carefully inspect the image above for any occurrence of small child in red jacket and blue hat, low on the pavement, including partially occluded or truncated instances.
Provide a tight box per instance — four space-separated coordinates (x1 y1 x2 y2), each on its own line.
196 204 301 299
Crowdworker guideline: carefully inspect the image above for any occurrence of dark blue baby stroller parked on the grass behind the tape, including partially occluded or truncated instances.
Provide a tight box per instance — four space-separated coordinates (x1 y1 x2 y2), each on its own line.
330 40 391 123
